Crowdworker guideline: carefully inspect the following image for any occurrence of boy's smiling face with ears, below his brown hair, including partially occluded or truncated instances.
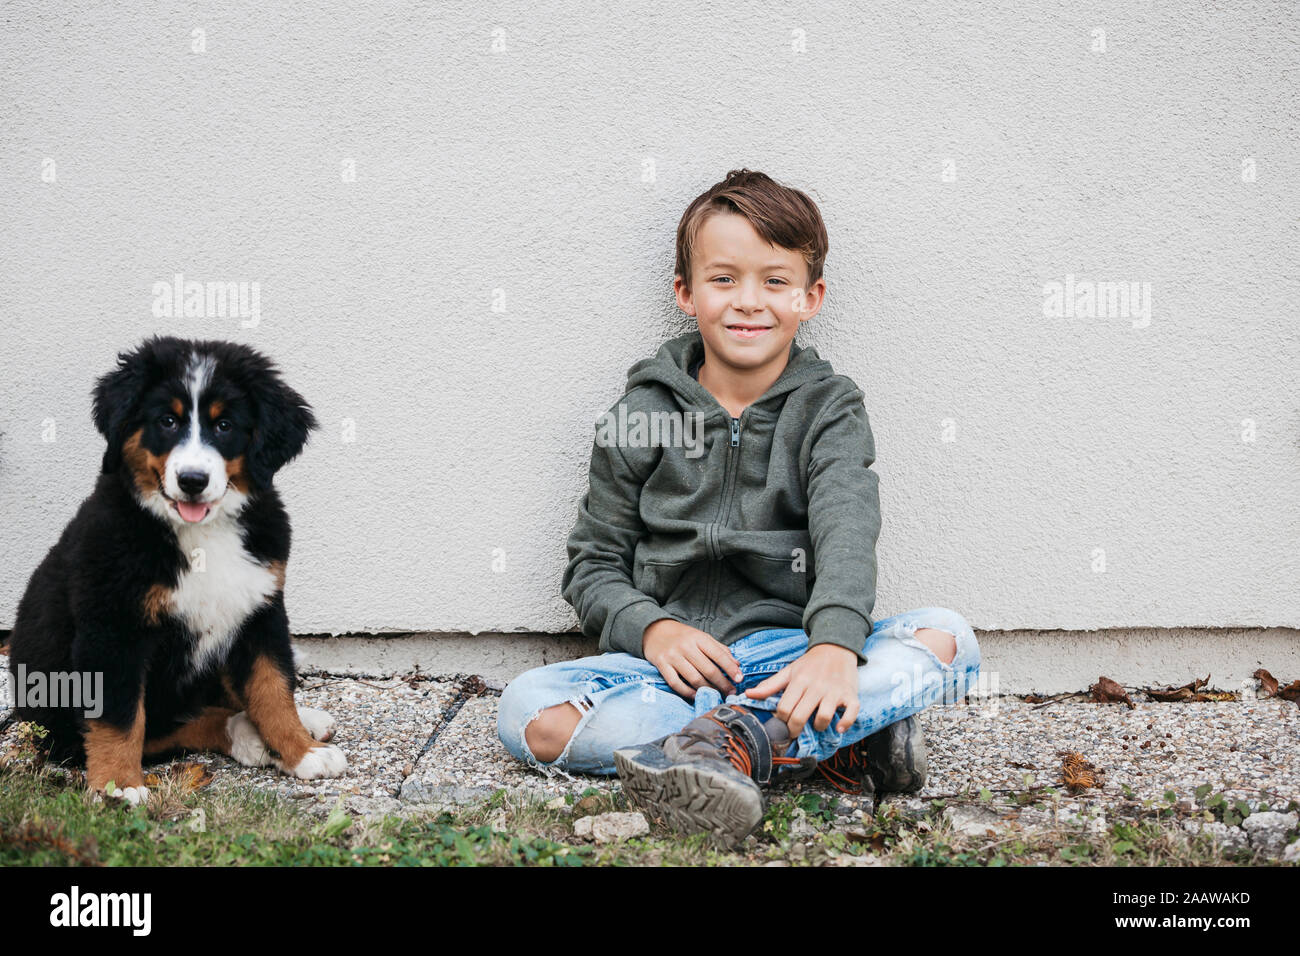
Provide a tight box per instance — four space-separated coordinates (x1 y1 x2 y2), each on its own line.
673 212 826 375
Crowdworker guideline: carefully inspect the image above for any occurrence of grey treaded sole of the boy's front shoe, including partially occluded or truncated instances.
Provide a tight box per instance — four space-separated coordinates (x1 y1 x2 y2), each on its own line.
614 745 763 847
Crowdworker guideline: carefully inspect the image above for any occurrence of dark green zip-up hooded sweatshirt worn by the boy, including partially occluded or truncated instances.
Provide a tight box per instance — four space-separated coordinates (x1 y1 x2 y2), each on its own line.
563 332 880 661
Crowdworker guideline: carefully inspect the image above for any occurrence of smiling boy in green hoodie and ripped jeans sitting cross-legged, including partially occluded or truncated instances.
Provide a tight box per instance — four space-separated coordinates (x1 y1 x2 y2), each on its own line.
498 169 979 844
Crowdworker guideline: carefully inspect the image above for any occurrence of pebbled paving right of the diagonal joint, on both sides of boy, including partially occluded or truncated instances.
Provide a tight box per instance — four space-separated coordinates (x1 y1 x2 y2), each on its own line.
404 697 1300 826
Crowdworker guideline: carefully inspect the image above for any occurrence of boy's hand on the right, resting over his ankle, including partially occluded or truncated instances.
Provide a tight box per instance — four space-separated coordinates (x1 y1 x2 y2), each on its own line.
745 644 858 737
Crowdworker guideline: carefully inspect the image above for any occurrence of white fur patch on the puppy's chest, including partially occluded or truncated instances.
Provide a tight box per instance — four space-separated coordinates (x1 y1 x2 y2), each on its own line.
172 522 278 672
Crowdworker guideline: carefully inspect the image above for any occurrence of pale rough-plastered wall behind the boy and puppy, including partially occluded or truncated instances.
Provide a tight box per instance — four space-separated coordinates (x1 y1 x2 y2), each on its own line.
0 0 1300 632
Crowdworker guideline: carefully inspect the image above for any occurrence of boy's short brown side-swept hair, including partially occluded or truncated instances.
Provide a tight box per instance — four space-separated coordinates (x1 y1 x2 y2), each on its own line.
676 169 831 286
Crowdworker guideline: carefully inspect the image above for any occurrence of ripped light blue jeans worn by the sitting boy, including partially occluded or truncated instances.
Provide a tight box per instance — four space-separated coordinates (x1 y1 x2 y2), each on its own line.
497 607 980 774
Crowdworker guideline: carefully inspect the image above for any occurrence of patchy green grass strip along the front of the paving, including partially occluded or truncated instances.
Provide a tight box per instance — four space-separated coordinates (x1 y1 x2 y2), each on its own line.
0 723 1283 866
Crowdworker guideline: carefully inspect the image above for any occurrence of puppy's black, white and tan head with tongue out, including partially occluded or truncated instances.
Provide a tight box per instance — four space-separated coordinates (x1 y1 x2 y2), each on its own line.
94 337 316 524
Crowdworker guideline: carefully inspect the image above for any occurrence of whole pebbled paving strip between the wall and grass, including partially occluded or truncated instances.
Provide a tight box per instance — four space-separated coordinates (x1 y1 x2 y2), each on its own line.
0 675 1300 830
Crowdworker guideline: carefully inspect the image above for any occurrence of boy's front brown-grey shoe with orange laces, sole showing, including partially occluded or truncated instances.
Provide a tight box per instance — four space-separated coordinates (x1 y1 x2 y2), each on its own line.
614 704 811 847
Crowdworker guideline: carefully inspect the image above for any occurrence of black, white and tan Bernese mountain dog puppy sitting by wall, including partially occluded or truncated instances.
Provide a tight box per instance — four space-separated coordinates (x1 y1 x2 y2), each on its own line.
9 337 347 804
